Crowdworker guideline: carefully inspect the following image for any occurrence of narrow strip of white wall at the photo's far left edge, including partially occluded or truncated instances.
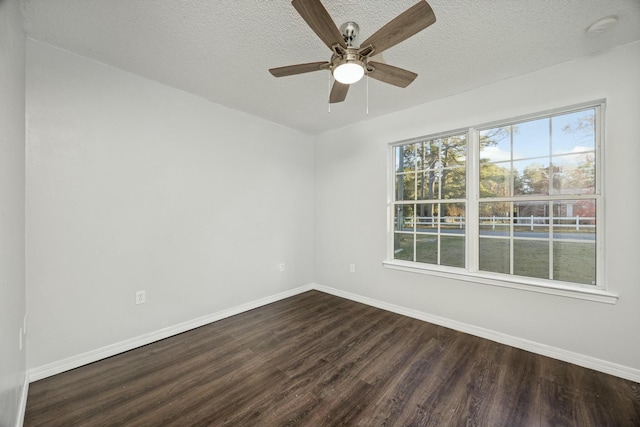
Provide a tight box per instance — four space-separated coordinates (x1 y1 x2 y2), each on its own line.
0 0 26 426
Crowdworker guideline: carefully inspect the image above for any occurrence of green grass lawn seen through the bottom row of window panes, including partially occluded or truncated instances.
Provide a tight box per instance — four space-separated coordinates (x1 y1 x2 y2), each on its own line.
395 234 596 285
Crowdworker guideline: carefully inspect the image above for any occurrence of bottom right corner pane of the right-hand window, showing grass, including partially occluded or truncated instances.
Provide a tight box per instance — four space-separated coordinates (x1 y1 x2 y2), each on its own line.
553 242 596 285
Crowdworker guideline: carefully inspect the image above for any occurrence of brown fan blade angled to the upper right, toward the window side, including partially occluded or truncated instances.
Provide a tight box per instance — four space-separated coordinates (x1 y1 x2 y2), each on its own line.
360 0 436 55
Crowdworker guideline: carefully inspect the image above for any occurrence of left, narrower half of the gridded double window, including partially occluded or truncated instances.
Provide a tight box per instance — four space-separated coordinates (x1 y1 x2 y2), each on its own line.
393 134 467 268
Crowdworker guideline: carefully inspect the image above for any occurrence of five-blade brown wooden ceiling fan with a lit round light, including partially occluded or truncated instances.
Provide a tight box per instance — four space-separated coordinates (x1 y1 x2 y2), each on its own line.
269 0 436 103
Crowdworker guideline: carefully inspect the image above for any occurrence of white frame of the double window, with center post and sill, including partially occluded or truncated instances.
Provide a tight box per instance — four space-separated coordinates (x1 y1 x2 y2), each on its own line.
383 100 618 304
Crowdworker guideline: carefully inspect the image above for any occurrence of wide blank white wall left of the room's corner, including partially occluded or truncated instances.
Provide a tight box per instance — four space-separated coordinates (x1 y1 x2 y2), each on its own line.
26 40 313 368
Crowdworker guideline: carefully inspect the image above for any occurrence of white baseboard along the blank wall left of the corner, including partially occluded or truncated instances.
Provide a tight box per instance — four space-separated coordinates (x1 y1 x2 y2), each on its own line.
25 285 313 382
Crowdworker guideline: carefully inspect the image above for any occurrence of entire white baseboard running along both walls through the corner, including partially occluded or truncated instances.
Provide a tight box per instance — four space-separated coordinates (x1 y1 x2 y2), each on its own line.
22 283 640 386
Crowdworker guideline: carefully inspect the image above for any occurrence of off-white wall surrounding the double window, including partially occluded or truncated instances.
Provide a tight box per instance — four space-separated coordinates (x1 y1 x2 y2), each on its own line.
315 43 640 372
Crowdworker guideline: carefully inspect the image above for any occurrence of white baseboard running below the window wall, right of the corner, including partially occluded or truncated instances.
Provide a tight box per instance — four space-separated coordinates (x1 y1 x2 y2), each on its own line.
311 283 640 382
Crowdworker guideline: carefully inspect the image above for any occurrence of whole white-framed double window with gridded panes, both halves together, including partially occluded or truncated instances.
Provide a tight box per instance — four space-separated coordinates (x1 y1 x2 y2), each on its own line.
386 103 604 300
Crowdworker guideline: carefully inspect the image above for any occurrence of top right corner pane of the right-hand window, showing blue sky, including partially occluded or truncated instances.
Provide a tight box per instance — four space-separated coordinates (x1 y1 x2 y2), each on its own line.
551 108 596 154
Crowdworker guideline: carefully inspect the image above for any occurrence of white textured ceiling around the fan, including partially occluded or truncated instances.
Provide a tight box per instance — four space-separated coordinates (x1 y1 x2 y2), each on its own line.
23 0 640 134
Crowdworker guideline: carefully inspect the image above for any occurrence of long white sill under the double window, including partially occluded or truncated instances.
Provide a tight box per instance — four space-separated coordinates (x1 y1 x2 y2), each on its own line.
382 260 618 304
